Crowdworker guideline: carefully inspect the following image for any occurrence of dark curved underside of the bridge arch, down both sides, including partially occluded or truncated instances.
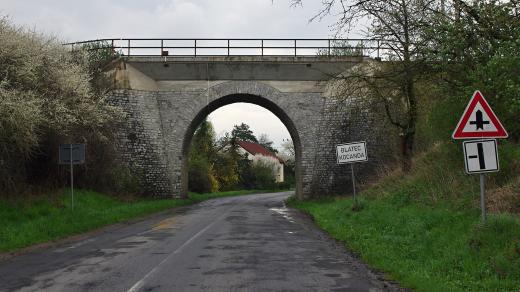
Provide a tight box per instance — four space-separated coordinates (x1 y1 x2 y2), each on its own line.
181 93 302 198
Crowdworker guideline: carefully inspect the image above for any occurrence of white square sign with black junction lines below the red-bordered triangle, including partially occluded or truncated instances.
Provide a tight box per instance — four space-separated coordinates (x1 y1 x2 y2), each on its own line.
462 139 499 174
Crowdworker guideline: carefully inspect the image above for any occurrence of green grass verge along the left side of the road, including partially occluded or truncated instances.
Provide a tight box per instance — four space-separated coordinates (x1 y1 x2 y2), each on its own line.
0 190 274 252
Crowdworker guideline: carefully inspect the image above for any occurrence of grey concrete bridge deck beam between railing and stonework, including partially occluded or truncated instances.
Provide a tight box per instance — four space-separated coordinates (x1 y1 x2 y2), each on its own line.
124 56 367 81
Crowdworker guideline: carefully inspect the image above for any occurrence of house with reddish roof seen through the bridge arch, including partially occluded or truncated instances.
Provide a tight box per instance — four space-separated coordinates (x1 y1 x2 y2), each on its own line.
237 141 283 182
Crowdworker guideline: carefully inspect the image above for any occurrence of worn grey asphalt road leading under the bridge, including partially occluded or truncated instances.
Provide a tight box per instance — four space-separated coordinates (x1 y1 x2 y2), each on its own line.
0 192 397 292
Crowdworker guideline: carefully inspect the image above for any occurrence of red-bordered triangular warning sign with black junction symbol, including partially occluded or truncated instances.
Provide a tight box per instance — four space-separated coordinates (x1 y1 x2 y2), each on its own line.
451 90 508 139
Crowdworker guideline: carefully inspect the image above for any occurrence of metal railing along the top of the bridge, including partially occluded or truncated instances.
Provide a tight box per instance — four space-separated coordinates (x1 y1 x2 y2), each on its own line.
65 38 384 58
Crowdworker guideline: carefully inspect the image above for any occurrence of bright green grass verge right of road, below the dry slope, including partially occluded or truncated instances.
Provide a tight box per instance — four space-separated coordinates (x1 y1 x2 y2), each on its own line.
290 197 520 291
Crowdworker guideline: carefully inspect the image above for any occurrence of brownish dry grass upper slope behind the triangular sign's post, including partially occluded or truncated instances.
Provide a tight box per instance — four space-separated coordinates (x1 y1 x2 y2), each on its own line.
360 143 520 215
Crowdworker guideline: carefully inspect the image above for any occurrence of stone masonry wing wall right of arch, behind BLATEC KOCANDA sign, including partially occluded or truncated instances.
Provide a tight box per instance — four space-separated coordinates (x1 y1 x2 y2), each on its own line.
311 98 396 197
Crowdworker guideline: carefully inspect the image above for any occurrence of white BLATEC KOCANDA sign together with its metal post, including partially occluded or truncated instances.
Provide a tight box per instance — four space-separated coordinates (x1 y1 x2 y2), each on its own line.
336 141 368 206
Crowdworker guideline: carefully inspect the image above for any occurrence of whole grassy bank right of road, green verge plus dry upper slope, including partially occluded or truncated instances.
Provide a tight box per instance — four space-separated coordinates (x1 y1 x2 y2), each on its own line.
289 144 520 291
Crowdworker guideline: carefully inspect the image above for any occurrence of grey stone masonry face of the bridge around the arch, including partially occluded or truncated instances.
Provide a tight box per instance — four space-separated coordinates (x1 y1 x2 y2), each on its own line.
107 81 392 198
